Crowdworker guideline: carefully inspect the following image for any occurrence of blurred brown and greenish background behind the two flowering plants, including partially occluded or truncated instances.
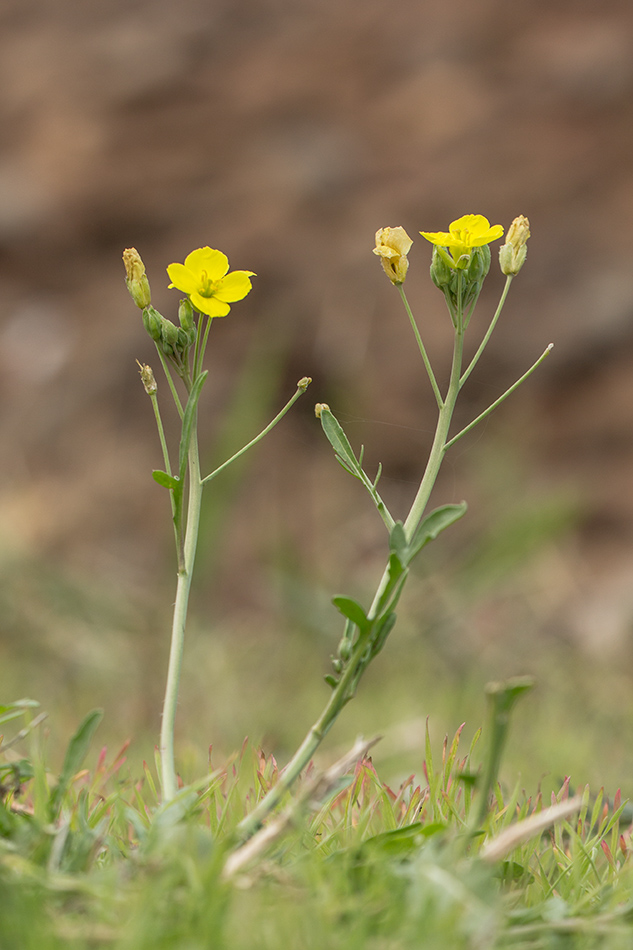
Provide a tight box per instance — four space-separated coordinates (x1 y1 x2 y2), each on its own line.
0 0 633 782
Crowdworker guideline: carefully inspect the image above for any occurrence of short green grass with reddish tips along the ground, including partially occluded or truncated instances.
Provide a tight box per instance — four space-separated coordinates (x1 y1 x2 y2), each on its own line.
0 692 633 950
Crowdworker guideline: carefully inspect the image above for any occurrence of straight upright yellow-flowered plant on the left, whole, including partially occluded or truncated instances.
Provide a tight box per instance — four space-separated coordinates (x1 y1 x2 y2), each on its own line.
123 247 311 802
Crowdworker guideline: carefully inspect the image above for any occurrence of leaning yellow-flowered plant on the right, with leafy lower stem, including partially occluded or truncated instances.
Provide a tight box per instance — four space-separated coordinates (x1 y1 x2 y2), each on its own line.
239 214 550 836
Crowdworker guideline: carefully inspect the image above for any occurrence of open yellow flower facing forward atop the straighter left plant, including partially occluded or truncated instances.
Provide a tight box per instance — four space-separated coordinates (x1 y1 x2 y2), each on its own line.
167 247 255 317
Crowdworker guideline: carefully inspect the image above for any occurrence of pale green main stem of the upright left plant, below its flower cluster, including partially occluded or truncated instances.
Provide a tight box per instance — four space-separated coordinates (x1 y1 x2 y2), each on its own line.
160 420 202 802
